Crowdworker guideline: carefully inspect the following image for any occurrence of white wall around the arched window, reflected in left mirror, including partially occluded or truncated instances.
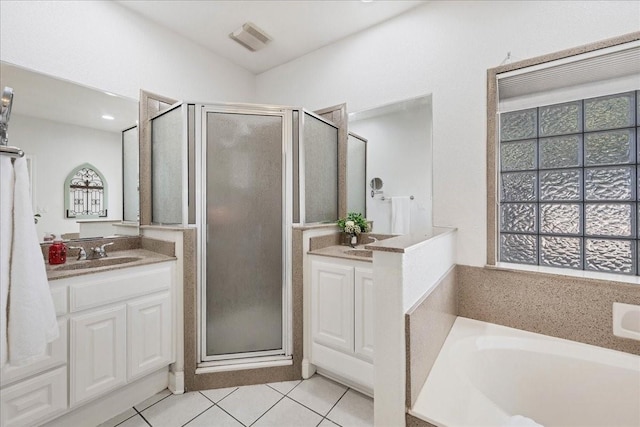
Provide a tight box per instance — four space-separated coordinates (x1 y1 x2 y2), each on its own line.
10 114 122 239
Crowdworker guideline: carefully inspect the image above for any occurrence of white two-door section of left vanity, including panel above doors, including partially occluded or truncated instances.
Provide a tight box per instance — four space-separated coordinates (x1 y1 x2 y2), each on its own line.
69 263 173 408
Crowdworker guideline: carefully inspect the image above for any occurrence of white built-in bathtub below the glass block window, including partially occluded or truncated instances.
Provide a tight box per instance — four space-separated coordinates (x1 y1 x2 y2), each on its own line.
409 317 640 427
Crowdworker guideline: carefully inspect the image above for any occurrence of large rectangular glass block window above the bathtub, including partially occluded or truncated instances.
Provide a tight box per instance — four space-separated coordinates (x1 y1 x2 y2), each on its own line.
499 91 640 275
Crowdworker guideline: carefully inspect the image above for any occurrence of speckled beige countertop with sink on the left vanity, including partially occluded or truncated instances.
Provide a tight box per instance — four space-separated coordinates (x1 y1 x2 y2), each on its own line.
45 249 176 280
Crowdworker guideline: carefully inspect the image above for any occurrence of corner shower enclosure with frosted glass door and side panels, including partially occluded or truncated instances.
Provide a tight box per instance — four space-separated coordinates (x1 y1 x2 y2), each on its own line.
151 103 338 370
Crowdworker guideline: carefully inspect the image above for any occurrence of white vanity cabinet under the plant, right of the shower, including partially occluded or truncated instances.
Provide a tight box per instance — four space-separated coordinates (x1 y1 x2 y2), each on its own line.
310 255 374 391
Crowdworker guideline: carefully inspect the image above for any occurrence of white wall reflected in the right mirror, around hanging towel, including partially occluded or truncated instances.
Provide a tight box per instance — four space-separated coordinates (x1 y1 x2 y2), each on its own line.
349 104 432 233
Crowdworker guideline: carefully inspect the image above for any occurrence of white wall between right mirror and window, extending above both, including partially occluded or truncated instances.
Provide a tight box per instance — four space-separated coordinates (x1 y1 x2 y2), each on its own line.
256 1 640 265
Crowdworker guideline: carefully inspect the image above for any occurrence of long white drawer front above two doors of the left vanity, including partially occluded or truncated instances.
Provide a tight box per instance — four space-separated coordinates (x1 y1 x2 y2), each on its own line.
69 262 175 313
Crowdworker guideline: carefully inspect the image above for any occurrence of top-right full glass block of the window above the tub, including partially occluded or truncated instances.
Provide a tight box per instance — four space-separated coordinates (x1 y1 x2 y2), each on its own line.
584 92 635 132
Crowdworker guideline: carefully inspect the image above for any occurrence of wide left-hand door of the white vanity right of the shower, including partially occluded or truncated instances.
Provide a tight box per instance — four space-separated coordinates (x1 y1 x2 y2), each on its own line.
311 261 353 354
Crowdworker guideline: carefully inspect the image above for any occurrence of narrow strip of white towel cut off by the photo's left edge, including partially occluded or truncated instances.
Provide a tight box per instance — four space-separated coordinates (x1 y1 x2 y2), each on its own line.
0 155 13 368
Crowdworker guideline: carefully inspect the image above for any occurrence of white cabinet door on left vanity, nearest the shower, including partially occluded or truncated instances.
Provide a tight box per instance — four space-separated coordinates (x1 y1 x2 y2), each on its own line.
127 292 172 379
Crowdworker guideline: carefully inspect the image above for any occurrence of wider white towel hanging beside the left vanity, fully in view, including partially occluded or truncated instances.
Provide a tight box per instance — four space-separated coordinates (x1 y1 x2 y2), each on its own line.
8 158 59 366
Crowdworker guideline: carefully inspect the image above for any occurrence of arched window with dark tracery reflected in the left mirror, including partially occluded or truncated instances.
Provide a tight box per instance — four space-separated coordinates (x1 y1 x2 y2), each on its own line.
65 163 107 218
